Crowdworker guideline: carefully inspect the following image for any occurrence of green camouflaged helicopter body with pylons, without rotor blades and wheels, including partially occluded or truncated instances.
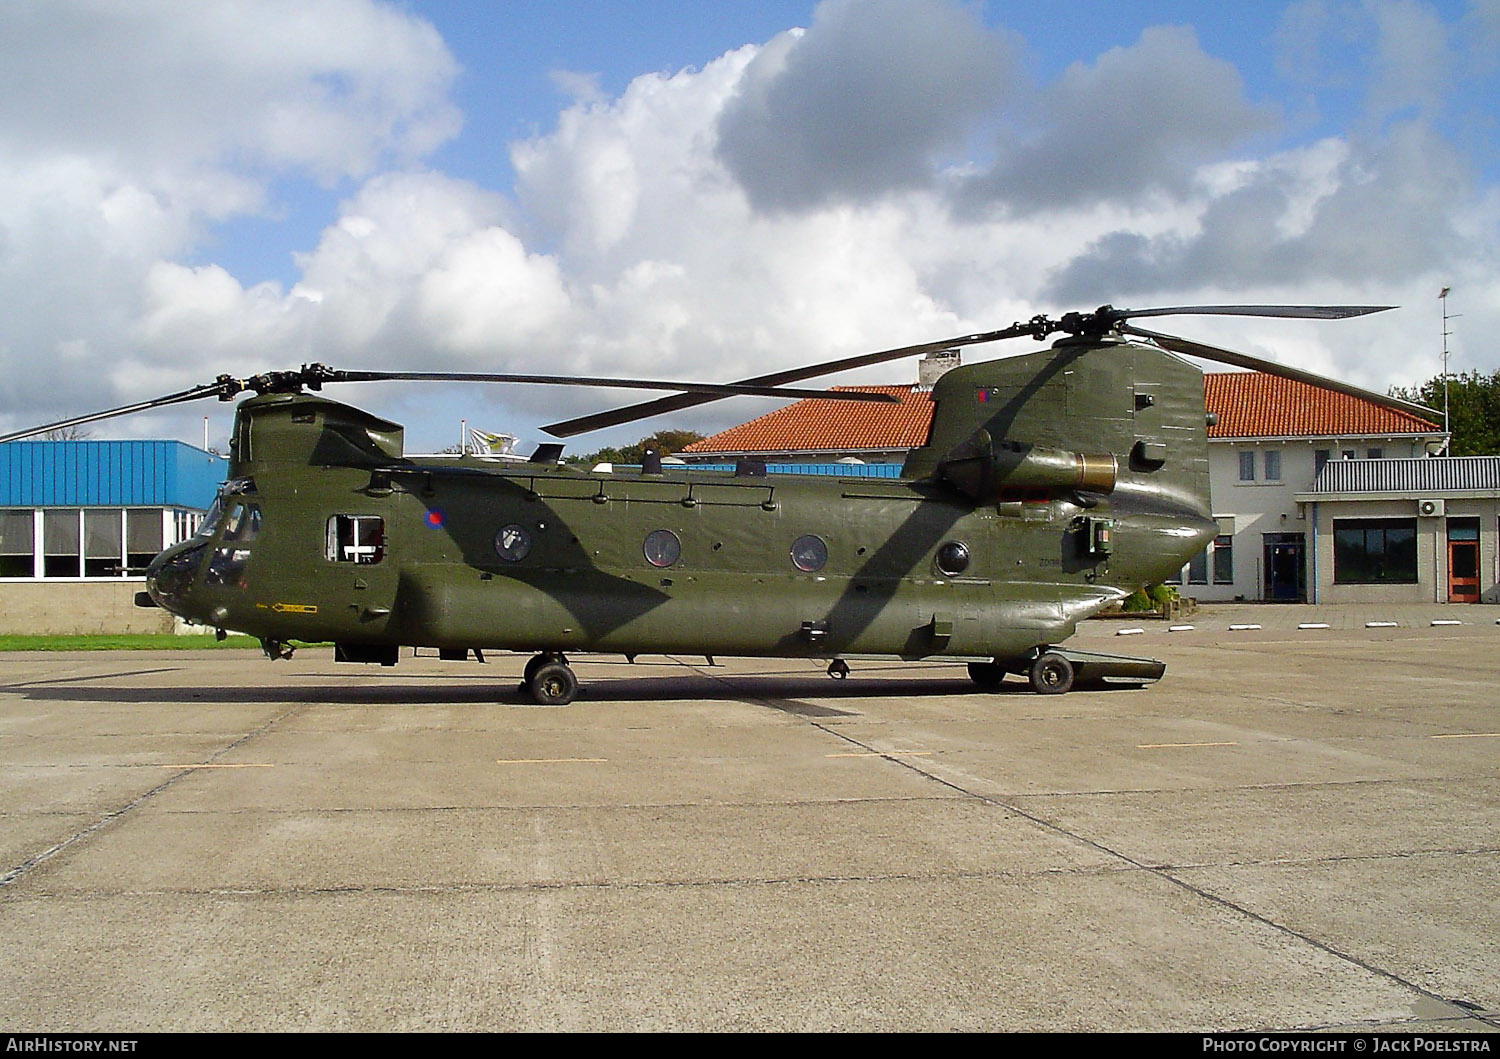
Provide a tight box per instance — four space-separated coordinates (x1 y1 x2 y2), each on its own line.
152 334 1215 659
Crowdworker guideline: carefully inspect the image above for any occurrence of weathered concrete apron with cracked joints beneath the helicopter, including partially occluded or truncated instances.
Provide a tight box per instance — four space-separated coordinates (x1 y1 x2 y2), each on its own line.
0 606 1500 1032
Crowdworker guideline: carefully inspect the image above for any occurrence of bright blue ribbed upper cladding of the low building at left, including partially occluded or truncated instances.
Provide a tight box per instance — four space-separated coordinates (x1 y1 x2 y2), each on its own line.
0 441 228 510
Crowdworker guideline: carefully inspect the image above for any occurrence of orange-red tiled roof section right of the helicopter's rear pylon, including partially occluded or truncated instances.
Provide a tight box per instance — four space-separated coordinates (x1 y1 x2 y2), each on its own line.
1203 372 1443 438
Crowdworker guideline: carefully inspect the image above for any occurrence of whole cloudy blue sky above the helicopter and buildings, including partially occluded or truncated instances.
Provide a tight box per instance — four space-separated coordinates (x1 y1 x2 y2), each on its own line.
0 0 1500 452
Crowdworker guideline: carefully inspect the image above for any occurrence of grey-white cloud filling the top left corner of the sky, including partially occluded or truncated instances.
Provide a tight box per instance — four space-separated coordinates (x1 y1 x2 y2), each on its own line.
0 0 459 181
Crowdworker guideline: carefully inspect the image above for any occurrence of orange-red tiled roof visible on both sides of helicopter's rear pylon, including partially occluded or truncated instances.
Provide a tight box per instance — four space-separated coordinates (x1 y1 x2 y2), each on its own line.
683 372 1442 455
